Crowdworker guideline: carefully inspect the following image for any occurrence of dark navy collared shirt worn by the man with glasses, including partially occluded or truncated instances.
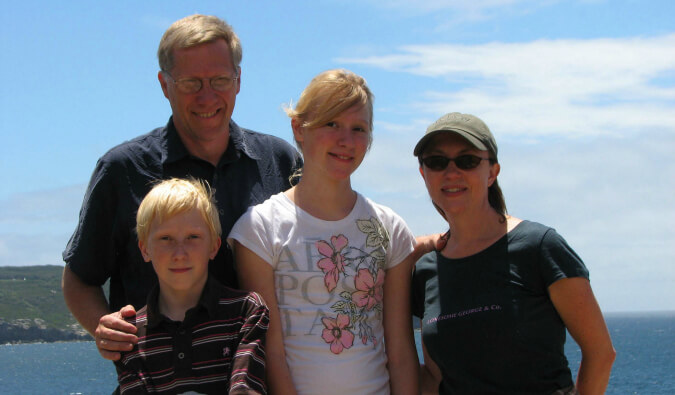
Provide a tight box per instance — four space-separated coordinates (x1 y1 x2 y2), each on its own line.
63 119 302 311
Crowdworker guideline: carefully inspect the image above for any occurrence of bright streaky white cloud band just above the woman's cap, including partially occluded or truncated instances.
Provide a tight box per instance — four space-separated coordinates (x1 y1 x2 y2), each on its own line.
338 34 675 138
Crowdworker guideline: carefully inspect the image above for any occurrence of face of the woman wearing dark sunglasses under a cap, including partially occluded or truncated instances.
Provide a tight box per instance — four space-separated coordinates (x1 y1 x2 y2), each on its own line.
420 133 499 219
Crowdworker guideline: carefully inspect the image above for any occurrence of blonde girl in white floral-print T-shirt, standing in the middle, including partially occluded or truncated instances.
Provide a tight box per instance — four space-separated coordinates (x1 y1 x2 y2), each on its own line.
229 70 418 395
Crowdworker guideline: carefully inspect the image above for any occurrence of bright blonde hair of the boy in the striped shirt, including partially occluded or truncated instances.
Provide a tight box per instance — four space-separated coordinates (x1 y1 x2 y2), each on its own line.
136 178 221 243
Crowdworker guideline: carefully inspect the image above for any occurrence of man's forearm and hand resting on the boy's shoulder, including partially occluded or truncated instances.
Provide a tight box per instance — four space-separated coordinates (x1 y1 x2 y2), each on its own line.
61 265 138 361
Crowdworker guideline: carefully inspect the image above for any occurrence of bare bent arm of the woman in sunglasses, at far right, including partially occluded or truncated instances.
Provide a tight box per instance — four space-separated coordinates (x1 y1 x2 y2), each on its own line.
548 277 616 395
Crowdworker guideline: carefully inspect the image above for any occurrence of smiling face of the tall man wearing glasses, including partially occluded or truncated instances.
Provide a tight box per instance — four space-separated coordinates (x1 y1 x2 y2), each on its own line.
159 40 240 150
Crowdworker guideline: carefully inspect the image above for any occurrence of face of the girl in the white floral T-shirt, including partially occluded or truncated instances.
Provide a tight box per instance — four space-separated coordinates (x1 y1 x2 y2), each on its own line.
291 106 372 181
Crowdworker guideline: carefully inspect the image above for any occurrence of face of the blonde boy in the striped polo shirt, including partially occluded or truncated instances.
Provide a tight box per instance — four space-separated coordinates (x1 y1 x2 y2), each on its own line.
138 209 220 295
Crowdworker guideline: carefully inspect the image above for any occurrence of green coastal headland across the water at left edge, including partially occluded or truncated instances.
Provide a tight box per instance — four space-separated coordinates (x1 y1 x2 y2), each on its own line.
0 265 92 344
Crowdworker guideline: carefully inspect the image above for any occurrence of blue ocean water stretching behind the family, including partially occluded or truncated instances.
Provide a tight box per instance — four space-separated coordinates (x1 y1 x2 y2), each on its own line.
0 312 675 395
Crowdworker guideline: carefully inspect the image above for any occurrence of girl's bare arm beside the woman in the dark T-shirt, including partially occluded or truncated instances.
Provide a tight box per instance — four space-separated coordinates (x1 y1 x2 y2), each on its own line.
383 254 419 394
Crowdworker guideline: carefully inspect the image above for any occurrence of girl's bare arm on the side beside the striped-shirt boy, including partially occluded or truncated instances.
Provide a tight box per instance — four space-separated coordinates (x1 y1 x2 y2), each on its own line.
234 241 296 395
